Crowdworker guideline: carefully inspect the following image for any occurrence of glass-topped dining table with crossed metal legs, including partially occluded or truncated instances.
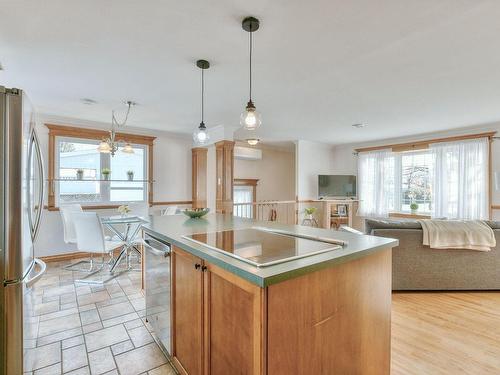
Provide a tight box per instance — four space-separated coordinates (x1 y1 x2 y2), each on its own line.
101 215 148 273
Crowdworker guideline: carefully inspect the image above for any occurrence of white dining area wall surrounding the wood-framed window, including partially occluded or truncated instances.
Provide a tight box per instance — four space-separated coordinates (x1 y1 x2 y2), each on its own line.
35 115 192 256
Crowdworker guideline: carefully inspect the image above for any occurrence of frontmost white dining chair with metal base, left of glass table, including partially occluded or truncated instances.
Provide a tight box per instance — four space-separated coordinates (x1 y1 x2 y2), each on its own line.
72 212 125 283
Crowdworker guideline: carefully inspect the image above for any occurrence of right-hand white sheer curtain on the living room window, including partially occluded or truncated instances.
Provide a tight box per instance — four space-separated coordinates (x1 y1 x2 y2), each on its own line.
430 138 489 220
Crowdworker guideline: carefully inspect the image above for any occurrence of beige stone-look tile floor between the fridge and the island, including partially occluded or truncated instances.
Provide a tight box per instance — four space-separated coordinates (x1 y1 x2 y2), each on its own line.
24 262 180 375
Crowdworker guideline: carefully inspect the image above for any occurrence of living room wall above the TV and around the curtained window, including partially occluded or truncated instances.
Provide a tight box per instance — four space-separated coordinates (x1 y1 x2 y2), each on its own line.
330 123 500 220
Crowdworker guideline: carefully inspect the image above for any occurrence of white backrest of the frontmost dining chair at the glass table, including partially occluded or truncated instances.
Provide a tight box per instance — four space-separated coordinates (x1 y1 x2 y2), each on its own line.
73 212 106 253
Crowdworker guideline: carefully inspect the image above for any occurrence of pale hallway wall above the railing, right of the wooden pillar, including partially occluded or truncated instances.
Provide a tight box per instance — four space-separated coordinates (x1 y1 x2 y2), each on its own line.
234 147 295 201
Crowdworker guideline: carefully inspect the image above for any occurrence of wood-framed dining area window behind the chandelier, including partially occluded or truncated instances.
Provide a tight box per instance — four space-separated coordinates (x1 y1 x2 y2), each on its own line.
47 125 154 209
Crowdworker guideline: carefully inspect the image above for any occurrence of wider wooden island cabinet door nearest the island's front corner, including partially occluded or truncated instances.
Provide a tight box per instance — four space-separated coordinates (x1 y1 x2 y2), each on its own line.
204 264 264 375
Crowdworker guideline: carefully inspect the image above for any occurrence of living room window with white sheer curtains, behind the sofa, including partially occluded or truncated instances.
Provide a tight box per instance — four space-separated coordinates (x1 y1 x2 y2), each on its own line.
358 137 490 219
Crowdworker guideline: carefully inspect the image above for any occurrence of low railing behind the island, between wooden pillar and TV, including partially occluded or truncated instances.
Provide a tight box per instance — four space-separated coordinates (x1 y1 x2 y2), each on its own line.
233 201 297 224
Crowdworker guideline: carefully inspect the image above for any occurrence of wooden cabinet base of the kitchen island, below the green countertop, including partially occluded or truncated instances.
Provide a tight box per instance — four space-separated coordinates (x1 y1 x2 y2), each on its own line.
172 246 392 375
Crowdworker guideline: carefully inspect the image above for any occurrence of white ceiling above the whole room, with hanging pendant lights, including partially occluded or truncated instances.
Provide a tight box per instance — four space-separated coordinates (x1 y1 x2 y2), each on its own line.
0 0 500 143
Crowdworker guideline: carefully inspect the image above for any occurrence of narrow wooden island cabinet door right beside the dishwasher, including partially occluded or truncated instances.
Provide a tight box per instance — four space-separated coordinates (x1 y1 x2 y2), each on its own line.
172 246 203 375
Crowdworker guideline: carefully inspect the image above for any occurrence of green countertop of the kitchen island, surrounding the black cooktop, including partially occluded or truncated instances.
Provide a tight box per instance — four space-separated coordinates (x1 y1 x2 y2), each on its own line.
143 214 398 287
